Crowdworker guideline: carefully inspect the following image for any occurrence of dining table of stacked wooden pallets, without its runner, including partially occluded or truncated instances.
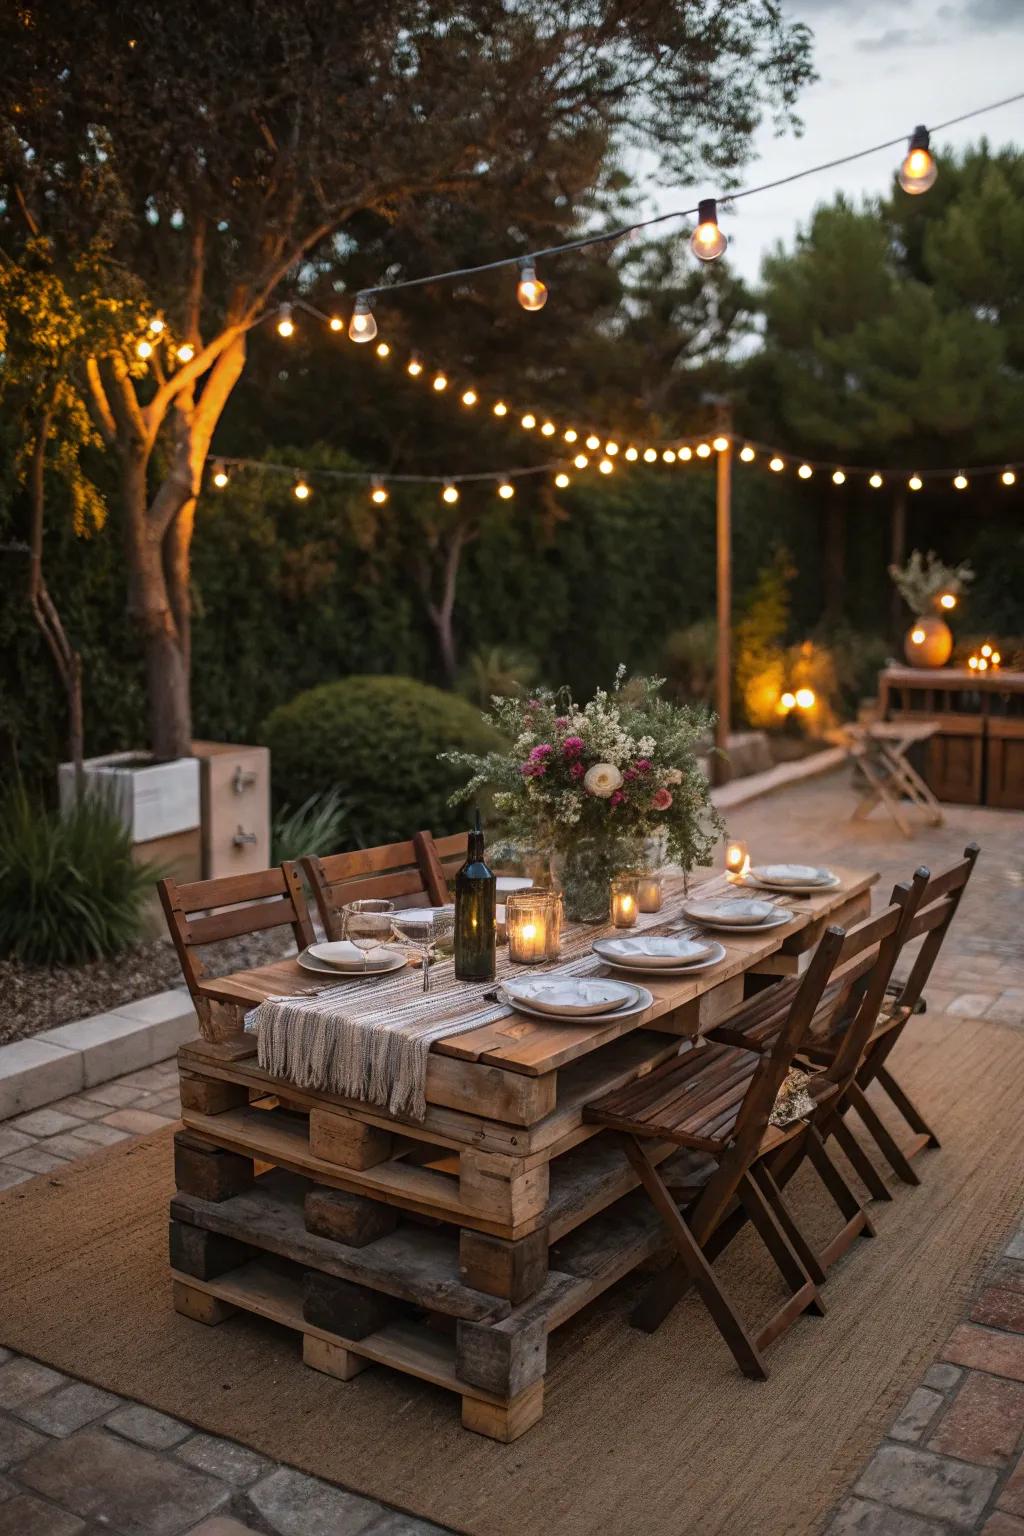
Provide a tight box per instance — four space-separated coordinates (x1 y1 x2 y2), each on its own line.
170 866 878 1441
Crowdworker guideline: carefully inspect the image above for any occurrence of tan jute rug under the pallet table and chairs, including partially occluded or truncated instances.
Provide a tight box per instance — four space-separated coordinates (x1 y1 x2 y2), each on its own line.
0 1015 1024 1536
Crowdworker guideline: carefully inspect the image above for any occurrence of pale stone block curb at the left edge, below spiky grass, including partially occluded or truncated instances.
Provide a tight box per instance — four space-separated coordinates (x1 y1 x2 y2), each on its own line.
0 988 198 1120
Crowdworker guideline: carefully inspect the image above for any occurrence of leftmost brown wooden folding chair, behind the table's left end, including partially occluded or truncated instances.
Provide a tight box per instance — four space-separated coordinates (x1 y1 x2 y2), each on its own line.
157 868 316 1025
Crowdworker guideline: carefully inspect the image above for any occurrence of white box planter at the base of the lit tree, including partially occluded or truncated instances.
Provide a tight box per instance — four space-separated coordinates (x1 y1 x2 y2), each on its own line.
57 753 201 843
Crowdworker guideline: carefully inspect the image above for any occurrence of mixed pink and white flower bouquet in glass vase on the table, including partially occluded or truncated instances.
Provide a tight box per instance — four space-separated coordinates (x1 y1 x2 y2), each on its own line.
444 667 723 922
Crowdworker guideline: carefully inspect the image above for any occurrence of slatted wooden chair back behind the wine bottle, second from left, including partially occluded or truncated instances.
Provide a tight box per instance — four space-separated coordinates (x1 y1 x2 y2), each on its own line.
302 833 465 938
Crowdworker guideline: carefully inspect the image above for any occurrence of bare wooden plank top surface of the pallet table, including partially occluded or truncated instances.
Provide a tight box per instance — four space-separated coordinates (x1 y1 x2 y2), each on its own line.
201 865 878 1077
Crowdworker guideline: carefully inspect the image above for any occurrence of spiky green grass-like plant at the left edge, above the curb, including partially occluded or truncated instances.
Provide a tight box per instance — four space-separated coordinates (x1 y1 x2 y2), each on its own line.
0 785 160 966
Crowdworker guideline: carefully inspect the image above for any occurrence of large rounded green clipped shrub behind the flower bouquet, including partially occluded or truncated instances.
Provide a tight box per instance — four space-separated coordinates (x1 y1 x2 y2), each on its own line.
263 677 500 848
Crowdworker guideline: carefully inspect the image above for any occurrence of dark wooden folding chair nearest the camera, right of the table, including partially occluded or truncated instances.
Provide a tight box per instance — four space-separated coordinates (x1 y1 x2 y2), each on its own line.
583 928 844 1379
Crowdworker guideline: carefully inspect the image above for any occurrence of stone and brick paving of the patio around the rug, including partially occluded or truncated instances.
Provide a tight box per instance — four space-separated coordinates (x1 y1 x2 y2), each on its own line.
0 774 1024 1536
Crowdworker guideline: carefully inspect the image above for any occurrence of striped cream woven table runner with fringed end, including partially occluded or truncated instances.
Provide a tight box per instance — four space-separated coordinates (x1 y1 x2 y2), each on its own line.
246 876 726 1120
